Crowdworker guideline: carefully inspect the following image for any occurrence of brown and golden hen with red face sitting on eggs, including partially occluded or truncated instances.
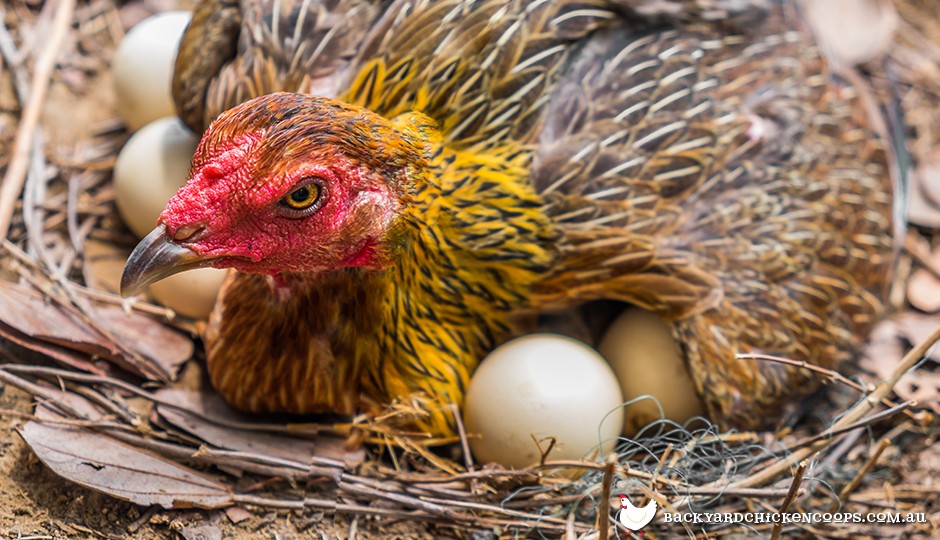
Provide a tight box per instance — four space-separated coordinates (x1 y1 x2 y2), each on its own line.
123 0 899 433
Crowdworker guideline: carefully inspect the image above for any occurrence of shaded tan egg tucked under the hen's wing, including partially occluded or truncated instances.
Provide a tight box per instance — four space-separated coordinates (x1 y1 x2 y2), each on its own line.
598 308 703 435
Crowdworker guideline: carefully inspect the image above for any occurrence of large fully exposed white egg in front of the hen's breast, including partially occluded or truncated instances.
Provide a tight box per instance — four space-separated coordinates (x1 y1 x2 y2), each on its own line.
464 334 623 467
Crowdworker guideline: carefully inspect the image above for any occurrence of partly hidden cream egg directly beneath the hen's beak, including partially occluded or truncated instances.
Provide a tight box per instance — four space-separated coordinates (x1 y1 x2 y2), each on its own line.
150 268 226 319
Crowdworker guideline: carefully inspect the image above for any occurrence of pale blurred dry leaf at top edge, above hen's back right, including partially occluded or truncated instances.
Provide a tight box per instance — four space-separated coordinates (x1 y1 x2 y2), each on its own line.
800 0 899 66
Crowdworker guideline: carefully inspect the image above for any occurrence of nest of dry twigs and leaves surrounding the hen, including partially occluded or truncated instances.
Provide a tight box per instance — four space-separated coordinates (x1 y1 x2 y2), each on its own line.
0 0 940 539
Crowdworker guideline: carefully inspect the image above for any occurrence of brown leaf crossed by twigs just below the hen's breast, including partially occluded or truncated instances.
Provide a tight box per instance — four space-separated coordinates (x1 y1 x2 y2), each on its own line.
156 388 364 467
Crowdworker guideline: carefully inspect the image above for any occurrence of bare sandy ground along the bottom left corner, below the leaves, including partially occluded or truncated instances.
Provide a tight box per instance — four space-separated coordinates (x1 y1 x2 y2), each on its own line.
0 385 436 540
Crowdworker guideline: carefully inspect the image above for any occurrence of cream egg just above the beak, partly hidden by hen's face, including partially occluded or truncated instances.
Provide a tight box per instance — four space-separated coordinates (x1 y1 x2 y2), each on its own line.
114 116 199 238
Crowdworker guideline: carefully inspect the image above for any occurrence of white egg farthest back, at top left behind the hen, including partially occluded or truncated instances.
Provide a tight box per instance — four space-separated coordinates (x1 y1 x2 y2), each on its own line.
111 11 192 131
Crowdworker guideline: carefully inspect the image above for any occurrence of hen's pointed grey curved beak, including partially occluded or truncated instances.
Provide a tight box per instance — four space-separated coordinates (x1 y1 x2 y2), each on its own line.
121 225 213 296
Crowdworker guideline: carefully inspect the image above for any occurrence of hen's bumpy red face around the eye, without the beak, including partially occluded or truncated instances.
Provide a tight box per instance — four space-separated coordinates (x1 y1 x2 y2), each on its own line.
159 94 414 276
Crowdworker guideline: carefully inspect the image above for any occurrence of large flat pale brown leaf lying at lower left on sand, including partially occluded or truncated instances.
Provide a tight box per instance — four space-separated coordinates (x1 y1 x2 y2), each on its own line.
19 421 232 509
